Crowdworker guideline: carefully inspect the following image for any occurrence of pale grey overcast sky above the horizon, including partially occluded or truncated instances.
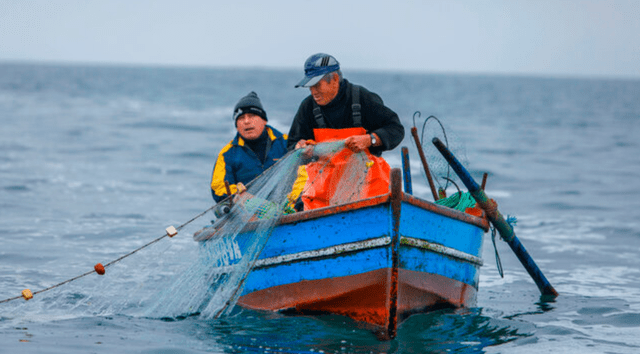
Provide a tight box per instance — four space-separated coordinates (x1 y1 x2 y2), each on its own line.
0 0 640 79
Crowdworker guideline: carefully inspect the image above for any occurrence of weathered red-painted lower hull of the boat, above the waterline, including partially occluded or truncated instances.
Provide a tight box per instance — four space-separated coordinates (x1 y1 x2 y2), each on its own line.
238 268 477 328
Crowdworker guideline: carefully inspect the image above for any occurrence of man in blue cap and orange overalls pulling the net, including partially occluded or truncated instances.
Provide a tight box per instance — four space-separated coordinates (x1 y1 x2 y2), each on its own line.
287 53 404 210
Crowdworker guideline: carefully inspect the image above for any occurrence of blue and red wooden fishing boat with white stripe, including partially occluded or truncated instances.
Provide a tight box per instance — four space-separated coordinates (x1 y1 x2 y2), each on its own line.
194 169 489 339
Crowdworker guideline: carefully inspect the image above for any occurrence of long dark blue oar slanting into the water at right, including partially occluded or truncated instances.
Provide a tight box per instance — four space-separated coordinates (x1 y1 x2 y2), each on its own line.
432 138 558 297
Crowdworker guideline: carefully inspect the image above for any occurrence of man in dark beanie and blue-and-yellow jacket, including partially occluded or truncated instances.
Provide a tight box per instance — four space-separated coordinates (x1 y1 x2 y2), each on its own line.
211 91 287 203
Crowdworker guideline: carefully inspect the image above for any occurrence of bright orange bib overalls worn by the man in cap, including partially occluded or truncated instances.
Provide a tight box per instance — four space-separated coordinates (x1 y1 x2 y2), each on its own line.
302 127 391 210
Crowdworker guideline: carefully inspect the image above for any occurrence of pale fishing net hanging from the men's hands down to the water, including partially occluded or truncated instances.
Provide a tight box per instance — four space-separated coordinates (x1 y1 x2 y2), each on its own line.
147 141 370 318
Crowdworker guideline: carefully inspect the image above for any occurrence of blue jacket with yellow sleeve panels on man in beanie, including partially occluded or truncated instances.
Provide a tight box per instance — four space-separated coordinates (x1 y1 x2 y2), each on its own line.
211 125 287 203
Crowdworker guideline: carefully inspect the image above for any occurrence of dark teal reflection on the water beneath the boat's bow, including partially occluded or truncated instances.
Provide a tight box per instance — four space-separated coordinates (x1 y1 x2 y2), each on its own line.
185 309 535 353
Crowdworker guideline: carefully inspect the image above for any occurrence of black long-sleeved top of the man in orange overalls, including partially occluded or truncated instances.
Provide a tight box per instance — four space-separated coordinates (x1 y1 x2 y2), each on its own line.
287 79 404 156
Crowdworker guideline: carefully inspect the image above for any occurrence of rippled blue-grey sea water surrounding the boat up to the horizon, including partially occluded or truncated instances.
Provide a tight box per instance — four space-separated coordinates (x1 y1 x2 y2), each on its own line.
0 63 640 354
